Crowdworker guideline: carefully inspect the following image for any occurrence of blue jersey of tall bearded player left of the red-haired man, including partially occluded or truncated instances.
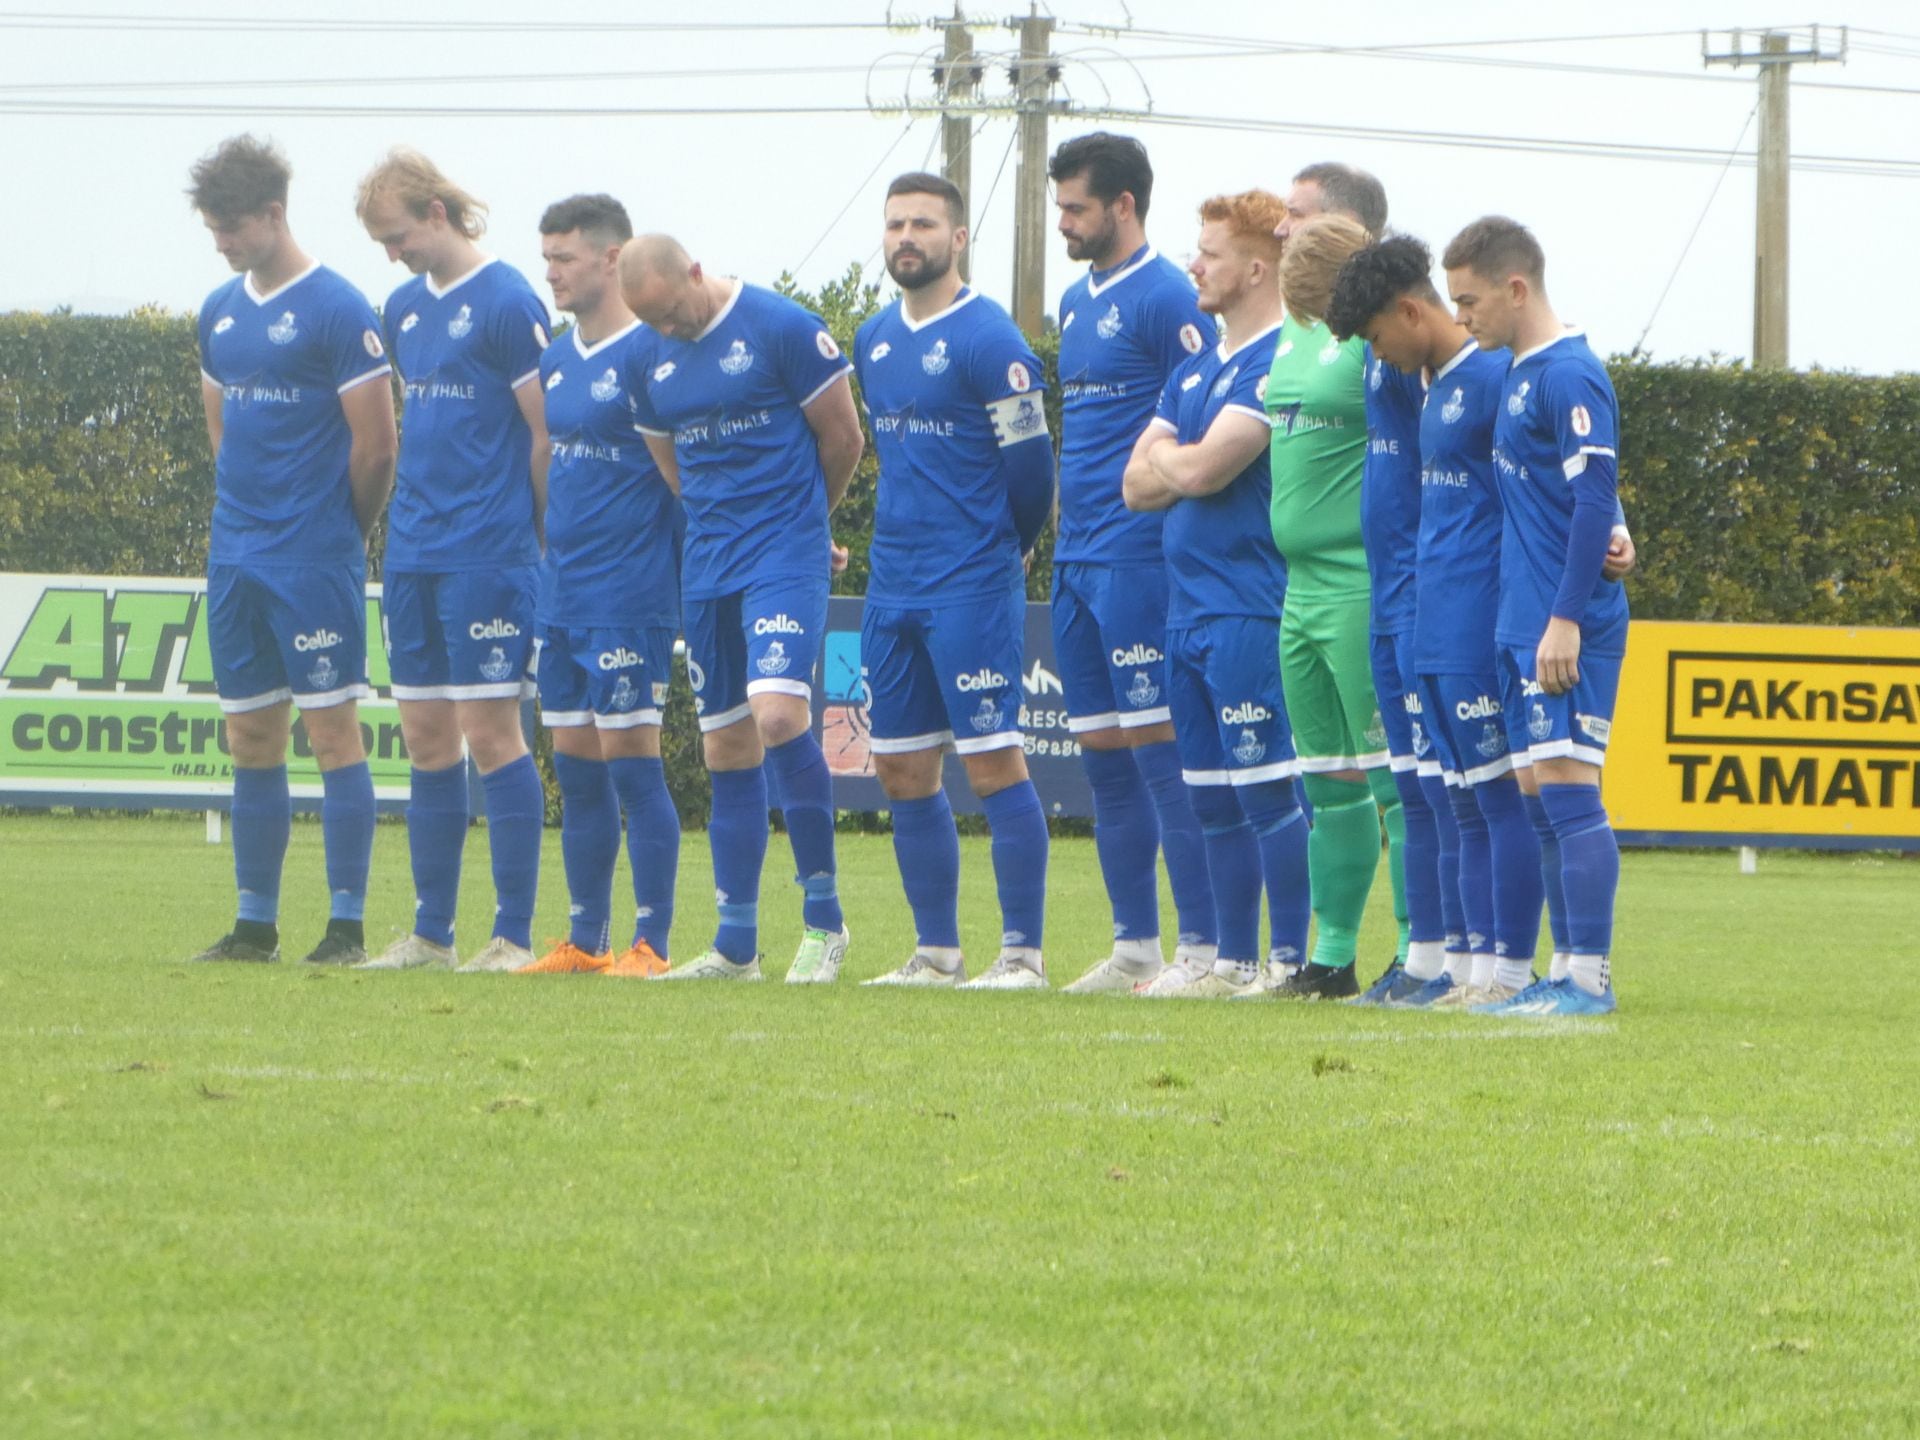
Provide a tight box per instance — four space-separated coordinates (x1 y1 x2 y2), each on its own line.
1054 248 1219 564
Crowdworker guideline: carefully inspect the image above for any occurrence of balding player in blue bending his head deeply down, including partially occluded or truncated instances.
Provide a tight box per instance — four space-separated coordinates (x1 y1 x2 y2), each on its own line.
620 234 866 985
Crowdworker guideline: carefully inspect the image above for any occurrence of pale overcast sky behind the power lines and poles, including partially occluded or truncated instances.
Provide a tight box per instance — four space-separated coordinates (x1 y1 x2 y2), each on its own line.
0 0 1920 372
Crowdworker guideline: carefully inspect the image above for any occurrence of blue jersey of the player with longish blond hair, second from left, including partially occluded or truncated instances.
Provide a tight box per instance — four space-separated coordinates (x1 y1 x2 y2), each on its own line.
382 259 547 574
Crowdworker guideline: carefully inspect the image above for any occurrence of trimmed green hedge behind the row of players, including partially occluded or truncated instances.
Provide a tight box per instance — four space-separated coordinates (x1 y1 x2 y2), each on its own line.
0 299 1920 824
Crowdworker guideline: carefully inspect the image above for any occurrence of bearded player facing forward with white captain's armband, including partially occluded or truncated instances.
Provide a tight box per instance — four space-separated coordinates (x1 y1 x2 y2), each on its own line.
854 171 1054 991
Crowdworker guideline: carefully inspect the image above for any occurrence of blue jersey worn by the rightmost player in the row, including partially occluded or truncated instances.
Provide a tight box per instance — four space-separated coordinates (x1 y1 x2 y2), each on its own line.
1494 330 1626 655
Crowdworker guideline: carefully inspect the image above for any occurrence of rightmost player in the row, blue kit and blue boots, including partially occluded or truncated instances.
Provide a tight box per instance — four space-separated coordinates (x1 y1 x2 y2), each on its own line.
1442 215 1626 1016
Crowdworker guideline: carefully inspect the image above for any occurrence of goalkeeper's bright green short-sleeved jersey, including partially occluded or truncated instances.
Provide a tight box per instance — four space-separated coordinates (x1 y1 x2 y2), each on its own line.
1265 317 1367 601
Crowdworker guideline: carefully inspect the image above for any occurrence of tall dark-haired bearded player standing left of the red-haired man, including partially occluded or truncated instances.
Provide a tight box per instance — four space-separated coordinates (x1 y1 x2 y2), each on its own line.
1048 131 1215 995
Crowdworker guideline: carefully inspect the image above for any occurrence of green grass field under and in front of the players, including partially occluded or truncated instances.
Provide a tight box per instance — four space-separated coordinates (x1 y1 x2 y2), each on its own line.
0 818 1920 1440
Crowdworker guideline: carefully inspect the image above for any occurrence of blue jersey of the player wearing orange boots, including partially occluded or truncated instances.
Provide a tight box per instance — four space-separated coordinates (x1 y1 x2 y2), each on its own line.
540 321 682 628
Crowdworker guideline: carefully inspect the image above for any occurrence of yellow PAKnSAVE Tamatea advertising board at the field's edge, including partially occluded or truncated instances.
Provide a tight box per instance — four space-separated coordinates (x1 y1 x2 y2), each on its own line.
1605 620 1920 849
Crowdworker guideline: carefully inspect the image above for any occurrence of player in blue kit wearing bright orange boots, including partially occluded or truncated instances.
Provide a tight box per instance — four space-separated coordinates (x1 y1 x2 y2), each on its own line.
522 196 682 979
